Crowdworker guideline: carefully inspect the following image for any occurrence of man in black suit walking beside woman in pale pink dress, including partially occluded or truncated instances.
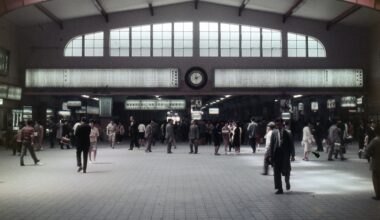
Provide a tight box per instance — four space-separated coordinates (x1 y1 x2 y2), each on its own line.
75 118 91 173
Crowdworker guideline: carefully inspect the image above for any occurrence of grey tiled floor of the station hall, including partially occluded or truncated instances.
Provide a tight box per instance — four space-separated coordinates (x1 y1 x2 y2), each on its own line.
0 144 380 220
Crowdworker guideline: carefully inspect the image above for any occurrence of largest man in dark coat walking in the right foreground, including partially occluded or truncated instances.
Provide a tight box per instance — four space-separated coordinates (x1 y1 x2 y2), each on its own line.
269 119 294 194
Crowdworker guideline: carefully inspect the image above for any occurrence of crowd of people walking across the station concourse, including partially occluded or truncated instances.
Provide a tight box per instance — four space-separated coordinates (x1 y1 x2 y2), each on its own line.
4 116 380 199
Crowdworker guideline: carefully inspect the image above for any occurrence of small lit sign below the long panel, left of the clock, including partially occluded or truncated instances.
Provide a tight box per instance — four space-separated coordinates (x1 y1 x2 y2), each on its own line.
125 99 186 110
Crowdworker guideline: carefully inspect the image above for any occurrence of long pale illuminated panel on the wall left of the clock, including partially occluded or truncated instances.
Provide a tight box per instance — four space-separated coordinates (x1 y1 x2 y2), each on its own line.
25 68 178 88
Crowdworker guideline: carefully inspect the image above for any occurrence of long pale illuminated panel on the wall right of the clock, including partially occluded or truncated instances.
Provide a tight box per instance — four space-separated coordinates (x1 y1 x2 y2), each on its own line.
215 69 363 88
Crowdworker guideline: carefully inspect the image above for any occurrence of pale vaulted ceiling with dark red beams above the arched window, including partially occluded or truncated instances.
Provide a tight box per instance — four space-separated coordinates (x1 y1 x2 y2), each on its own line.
0 0 380 27
